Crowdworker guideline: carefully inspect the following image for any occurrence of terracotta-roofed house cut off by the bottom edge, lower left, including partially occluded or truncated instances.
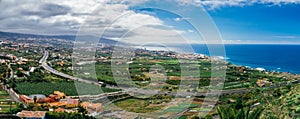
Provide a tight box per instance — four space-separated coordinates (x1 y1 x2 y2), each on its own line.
17 110 46 119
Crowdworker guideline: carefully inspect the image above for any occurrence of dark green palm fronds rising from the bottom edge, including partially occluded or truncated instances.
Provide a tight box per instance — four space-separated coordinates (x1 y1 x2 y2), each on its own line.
217 106 264 119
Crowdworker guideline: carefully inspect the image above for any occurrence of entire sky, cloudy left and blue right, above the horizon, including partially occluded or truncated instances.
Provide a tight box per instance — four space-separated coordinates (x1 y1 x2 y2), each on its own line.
0 0 300 45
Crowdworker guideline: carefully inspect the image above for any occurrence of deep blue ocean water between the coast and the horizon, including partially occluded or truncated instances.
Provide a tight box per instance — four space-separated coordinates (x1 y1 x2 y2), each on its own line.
192 44 300 74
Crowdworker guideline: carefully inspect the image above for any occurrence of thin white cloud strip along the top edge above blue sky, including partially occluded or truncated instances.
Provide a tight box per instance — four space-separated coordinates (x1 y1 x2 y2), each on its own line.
177 0 300 9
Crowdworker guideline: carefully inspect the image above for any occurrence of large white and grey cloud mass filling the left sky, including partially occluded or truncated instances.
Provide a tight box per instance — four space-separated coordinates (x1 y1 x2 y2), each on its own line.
0 0 190 44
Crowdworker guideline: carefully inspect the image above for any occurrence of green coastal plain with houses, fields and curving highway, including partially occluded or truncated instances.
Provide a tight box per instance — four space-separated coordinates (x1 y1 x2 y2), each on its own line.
0 32 300 119
